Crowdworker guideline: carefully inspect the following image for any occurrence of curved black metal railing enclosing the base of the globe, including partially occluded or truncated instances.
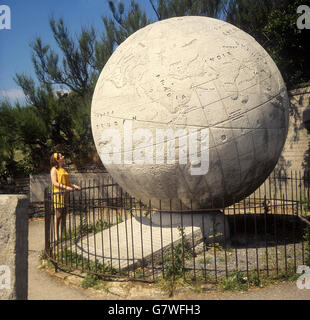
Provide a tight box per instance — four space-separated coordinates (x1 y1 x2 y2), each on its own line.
45 173 310 282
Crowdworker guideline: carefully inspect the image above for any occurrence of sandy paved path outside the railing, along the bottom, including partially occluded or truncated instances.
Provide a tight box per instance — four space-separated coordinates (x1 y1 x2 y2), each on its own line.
28 220 310 300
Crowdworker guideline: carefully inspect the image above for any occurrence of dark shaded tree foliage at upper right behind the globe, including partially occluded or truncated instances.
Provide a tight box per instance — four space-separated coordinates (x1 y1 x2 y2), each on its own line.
226 0 310 89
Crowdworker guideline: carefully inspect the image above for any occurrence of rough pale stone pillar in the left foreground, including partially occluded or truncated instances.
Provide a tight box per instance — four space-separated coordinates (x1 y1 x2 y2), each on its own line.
0 195 28 300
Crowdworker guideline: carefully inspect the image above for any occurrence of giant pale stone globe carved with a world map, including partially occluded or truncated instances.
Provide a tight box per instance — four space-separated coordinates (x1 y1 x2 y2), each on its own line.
91 16 289 210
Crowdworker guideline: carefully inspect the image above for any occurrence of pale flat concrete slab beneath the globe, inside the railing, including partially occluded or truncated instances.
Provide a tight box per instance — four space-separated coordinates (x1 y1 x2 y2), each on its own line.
73 217 203 270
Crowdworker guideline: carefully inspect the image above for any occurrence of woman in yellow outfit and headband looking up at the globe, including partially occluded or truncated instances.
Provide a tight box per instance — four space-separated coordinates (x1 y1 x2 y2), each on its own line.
50 152 81 241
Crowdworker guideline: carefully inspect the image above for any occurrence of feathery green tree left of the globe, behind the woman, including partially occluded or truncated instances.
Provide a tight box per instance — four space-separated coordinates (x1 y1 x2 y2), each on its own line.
15 15 101 172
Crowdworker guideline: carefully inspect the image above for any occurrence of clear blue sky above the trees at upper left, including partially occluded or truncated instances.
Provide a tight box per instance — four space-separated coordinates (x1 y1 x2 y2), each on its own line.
0 0 154 103
